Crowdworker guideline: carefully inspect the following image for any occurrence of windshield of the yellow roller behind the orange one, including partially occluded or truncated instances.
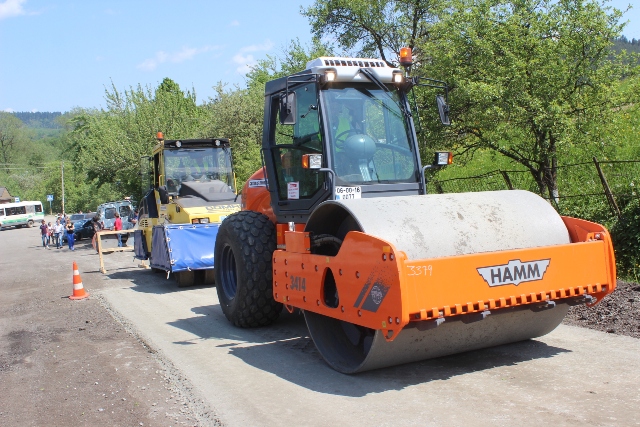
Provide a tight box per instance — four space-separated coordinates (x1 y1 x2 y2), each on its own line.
164 147 235 194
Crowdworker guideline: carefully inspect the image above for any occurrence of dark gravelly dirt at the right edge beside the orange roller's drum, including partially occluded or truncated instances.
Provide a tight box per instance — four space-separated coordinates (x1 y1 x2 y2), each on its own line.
563 280 640 338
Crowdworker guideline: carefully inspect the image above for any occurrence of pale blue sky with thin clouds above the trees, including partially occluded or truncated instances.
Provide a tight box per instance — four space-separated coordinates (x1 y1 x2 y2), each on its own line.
0 0 640 111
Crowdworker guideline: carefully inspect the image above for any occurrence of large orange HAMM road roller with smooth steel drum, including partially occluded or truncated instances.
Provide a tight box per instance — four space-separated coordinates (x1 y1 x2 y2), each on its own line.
215 50 616 374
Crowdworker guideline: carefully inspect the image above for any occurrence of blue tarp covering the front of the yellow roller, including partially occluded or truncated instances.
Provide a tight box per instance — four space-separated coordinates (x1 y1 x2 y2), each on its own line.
151 224 220 273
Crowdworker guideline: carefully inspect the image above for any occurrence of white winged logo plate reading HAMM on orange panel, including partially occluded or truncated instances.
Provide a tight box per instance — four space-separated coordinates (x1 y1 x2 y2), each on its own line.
477 259 551 286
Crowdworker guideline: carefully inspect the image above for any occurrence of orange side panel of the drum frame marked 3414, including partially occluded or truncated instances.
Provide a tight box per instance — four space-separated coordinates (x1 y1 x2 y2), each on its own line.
273 232 408 336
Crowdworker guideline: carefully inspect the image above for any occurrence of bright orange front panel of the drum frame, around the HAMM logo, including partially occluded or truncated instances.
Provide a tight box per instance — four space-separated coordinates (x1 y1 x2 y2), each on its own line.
402 241 615 313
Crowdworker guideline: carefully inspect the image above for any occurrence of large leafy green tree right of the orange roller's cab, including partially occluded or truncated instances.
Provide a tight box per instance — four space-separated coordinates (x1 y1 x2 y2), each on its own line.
419 0 637 197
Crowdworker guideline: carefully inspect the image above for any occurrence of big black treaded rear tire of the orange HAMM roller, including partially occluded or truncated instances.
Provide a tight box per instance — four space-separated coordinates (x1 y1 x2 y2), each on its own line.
214 211 282 328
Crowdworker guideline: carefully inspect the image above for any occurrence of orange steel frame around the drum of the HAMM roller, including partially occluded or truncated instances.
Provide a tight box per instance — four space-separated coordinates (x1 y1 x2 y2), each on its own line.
273 217 616 342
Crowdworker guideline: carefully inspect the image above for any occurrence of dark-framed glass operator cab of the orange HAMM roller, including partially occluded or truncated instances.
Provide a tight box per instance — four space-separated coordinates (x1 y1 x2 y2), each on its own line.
263 57 446 222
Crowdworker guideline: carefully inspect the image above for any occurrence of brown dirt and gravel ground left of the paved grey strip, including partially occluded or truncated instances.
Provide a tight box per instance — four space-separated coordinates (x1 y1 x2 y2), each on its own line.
0 229 220 427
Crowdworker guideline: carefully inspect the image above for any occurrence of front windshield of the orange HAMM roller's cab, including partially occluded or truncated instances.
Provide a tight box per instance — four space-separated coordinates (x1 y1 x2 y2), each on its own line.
321 84 420 185
